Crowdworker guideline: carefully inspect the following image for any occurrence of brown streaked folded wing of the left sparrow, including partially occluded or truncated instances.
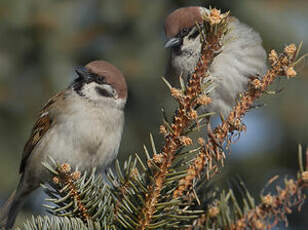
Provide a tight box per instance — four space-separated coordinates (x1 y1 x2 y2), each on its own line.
19 92 65 173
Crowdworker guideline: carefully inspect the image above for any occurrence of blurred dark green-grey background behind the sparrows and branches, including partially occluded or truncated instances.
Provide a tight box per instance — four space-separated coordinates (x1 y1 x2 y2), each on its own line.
0 0 308 230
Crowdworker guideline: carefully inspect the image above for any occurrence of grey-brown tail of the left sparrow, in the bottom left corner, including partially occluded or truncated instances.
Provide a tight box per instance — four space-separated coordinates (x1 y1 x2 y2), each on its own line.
0 190 24 229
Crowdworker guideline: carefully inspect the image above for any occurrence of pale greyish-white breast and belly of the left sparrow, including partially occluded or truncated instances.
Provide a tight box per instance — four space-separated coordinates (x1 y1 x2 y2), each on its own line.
37 102 124 170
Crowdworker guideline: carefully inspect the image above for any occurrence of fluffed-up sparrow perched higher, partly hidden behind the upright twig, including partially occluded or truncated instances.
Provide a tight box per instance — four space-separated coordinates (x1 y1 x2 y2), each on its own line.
164 6 267 117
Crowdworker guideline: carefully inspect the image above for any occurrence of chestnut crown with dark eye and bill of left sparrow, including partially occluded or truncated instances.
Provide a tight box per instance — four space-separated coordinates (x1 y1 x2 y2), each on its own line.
74 60 127 99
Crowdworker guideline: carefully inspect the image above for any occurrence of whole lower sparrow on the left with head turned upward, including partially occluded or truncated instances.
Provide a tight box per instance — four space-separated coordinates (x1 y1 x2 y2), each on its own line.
0 60 127 229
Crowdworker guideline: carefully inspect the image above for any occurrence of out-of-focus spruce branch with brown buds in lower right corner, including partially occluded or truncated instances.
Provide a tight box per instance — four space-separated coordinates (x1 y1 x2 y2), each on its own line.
186 146 308 230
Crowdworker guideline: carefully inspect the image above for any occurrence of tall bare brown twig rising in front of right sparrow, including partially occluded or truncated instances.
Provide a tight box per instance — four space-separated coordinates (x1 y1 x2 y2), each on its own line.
138 9 228 230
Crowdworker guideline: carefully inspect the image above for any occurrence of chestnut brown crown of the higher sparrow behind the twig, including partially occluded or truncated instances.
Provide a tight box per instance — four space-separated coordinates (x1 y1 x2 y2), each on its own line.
165 6 202 39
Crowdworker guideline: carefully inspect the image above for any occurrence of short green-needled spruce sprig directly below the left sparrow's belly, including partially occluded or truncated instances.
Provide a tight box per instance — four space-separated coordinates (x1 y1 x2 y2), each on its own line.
42 158 113 226
